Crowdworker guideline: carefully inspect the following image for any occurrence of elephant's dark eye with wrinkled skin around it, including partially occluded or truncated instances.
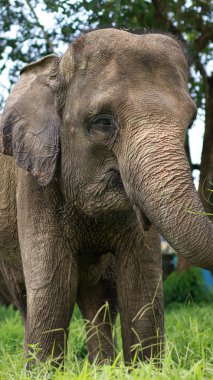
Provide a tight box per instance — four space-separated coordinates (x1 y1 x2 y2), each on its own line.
88 115 116 142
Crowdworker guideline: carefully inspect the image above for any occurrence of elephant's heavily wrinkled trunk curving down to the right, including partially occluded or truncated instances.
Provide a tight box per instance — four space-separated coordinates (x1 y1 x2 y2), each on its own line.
120 123 213 270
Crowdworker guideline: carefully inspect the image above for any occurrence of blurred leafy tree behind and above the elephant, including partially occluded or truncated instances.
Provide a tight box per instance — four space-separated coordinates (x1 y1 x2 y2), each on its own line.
0 0 213 267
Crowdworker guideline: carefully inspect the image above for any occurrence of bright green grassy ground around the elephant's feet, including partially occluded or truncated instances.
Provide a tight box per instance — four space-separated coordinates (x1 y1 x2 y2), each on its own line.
0 305 213 380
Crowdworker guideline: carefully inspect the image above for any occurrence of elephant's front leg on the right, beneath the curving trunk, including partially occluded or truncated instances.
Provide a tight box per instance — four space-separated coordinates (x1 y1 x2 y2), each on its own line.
117 228 164 363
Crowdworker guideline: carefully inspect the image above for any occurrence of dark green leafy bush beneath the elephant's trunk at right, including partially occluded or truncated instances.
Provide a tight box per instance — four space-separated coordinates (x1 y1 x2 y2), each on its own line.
164 267 213 306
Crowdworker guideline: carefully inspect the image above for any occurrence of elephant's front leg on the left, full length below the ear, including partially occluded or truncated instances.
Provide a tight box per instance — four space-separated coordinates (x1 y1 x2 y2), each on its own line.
17 174 78 362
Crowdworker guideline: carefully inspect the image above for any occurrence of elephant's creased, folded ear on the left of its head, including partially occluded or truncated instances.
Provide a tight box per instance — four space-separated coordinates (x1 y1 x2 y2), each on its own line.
0 55 60 186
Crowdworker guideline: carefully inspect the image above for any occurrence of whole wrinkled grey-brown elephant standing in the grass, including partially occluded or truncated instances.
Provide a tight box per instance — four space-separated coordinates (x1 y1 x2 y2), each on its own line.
0 29 213 362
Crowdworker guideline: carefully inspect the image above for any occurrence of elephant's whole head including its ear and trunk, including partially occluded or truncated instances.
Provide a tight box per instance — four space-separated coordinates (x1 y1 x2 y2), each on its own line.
1 29 213 268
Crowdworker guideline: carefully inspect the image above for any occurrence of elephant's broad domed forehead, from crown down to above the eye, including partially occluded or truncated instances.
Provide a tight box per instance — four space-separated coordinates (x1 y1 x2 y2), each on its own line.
64 29 193 121
